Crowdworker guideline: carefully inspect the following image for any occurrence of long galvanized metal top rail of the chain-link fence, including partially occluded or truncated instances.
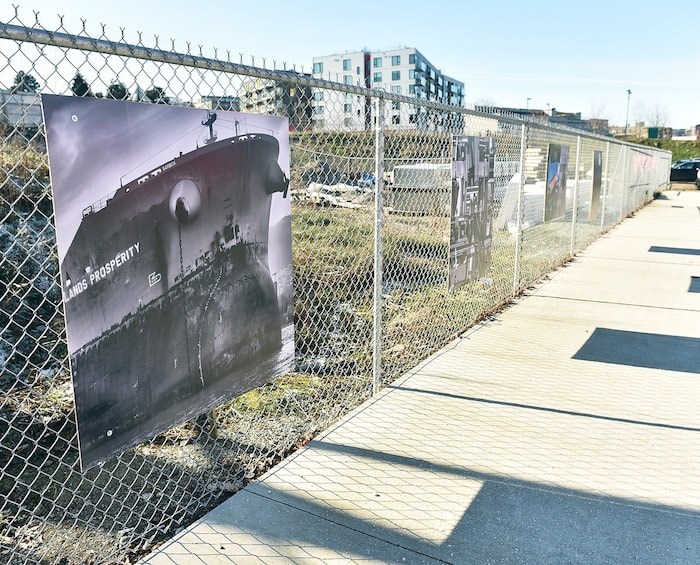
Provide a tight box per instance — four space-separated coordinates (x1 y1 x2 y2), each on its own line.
0 22 670 154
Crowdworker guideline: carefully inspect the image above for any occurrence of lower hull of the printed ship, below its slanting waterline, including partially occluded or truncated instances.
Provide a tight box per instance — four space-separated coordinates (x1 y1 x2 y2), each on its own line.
72 253 289 464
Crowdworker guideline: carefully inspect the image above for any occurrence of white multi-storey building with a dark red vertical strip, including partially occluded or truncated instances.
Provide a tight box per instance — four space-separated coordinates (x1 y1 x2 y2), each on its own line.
312 47 464 130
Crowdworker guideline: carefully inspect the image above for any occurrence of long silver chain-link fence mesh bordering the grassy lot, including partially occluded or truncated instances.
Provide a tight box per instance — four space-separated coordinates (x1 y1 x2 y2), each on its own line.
0 9 670 563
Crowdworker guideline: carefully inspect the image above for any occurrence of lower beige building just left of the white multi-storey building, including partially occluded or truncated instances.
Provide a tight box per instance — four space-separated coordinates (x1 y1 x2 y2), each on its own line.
240 71 312 131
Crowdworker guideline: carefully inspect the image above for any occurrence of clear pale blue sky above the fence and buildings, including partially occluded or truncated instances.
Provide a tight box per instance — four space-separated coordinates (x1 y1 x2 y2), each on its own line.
0 0 700 128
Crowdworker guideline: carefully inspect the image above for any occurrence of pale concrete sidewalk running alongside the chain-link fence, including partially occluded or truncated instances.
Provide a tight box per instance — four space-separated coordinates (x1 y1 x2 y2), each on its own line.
146 191 700 564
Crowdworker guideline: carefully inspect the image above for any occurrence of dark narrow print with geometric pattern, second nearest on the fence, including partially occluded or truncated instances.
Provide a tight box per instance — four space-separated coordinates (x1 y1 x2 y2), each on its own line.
449 136 495 290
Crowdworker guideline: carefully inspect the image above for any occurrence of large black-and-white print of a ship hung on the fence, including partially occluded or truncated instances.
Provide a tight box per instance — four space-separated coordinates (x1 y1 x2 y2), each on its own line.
42 95 294 468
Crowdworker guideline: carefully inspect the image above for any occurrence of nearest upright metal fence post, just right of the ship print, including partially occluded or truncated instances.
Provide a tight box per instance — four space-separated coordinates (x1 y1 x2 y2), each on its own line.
372 97 384 395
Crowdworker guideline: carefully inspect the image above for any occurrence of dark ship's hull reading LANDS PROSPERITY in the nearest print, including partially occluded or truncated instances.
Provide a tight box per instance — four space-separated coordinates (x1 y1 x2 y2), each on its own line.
61 131 292 467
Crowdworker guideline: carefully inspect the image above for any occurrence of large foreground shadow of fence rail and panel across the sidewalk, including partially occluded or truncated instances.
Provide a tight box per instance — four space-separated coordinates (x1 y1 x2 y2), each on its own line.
147 441 700 564
